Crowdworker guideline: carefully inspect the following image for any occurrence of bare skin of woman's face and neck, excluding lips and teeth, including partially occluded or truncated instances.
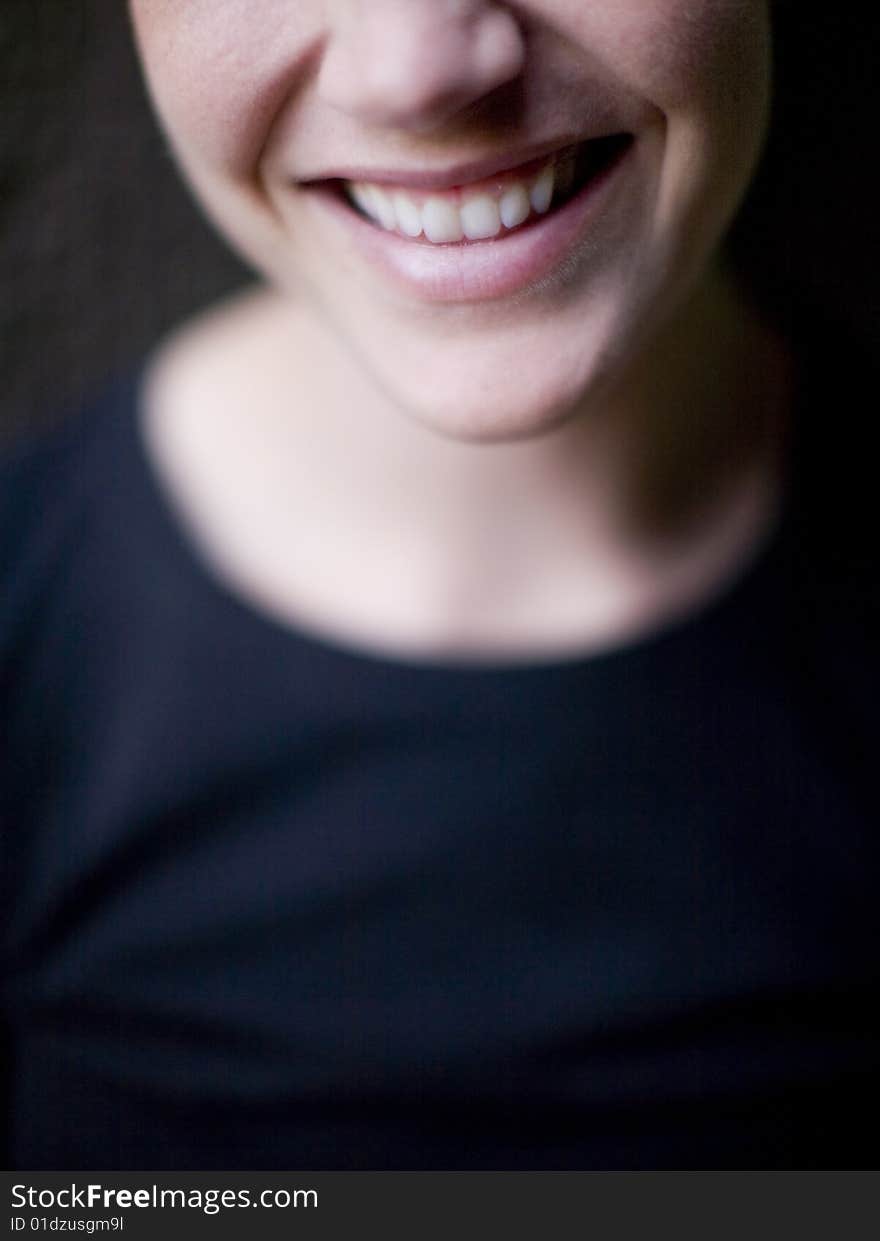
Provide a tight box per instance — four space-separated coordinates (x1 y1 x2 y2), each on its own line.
130 0 787 653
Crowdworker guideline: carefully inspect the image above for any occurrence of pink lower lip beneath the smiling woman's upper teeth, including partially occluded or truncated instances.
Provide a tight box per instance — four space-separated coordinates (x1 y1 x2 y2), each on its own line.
301 141 634 303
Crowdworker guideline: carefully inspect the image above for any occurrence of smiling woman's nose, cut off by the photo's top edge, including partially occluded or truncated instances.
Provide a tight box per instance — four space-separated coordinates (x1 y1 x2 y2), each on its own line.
317 0 525 133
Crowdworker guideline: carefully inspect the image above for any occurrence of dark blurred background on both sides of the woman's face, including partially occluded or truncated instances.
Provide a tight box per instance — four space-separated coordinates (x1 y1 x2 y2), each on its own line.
0 0 880 438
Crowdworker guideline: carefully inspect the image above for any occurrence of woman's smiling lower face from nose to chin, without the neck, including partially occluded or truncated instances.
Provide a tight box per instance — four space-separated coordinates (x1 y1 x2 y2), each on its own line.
132 0 770 439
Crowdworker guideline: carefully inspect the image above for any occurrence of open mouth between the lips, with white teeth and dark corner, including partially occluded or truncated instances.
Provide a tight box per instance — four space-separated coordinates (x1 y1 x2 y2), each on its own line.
334 134 632 246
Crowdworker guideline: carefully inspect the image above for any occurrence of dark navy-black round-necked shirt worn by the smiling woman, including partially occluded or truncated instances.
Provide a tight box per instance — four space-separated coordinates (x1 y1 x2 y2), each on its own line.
0 337 880 1169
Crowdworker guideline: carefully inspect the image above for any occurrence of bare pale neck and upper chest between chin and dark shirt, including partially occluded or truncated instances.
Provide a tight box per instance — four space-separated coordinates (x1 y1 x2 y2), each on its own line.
142 263 787 650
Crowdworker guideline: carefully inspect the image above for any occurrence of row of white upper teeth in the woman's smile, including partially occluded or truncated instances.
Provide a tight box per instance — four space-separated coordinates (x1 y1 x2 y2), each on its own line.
348 164 560 244
